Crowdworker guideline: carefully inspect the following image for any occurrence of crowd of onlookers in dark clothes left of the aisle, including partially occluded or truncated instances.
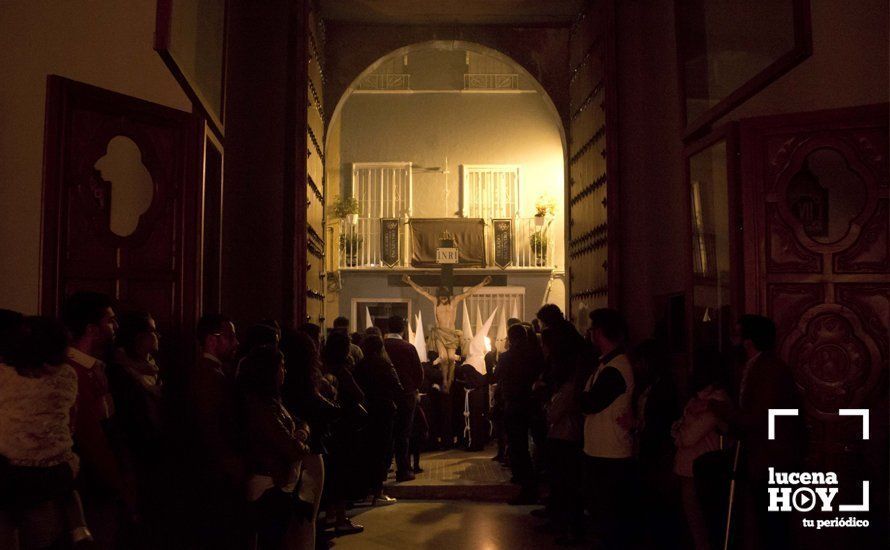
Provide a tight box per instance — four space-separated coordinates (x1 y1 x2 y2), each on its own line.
0 292 434 549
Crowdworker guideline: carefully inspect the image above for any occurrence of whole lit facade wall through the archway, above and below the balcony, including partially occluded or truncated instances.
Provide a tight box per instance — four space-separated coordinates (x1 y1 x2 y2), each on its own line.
328 50 565 326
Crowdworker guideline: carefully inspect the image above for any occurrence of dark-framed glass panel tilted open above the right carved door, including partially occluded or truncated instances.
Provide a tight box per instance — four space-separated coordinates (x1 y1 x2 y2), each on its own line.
674 0 813 138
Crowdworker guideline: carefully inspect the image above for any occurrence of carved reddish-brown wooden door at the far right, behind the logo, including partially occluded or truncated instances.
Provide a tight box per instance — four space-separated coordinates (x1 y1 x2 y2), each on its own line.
741 105 890 540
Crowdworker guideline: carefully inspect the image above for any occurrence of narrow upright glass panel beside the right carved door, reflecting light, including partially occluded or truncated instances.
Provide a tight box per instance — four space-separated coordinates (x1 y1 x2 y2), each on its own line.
683 124 744 364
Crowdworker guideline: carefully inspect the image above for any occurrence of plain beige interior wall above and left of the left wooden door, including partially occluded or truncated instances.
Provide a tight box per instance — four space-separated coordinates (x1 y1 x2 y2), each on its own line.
0 0 191 313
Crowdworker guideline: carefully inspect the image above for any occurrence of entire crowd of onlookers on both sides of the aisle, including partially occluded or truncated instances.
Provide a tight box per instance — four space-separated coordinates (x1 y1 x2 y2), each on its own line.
0 292 801 550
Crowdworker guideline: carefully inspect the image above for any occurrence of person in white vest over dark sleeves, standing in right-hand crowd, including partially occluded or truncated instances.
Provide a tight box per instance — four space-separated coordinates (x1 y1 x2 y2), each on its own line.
581 308 636 548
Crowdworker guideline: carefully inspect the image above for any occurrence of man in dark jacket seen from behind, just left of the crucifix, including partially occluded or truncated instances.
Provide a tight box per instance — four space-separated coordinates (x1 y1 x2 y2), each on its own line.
383 315 423 481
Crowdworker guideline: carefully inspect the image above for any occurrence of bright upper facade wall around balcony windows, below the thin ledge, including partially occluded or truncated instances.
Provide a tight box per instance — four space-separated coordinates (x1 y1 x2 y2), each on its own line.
341 92 564 268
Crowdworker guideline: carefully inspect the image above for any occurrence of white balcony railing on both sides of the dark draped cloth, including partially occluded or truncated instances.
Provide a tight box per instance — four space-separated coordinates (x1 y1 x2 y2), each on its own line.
337 218 554 269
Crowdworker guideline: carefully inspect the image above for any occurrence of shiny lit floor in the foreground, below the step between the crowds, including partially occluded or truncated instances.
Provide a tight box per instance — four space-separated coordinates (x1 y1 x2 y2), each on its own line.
334 501 556 550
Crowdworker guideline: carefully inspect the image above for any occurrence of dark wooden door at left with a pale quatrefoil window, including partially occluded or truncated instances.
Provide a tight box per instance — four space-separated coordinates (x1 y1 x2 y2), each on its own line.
41 76 202 349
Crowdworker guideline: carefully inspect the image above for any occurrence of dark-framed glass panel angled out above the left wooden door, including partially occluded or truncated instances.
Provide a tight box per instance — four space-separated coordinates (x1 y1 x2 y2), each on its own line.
155 0 226 137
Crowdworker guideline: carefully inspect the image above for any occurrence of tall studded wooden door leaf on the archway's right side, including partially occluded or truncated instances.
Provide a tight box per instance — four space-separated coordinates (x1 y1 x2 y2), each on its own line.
565 0 620 327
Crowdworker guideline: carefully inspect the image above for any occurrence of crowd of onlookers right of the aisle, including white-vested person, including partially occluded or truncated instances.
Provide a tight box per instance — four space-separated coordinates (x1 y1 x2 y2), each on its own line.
478 305 804 550
